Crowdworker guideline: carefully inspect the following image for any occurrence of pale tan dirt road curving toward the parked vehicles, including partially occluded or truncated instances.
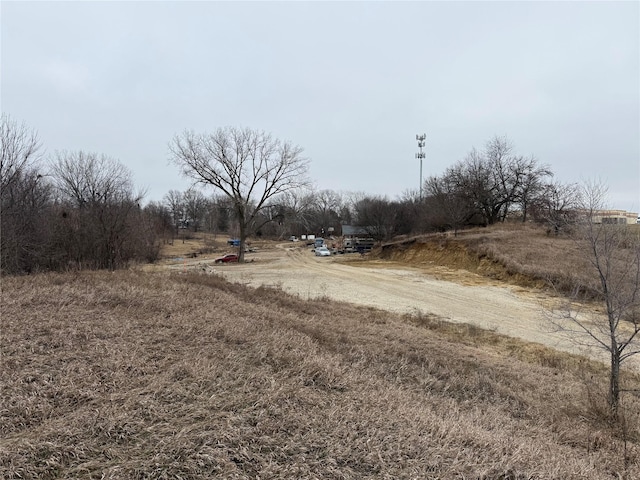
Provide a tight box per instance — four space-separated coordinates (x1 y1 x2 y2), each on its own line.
173 244 624 368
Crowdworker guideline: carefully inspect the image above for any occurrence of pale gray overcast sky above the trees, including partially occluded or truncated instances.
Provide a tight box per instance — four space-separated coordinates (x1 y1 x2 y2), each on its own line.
0 1 640 211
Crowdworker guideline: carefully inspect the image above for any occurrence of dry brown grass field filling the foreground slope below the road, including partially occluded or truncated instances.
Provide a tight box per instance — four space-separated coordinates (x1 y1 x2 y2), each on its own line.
0 271 640 479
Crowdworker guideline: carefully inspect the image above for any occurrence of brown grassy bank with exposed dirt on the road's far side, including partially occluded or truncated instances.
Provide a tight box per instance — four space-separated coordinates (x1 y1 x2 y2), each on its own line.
379 223 640 299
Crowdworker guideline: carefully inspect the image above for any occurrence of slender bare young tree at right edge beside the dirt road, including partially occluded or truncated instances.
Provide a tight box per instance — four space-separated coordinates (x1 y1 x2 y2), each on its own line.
556 184 640 418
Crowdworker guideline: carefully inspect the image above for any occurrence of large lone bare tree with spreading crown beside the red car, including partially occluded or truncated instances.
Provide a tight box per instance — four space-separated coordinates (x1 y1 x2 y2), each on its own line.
169 127 308 261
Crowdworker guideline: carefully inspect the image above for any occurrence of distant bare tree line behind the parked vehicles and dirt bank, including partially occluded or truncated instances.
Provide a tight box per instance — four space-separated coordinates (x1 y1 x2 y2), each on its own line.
164 137 580 246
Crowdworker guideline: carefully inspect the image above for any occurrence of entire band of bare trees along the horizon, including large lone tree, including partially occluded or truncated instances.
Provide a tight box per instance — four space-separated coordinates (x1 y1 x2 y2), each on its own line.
0 114 578 273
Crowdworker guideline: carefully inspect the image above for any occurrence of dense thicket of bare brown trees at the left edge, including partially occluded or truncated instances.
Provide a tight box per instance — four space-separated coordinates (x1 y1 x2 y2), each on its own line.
0 115 159 274
